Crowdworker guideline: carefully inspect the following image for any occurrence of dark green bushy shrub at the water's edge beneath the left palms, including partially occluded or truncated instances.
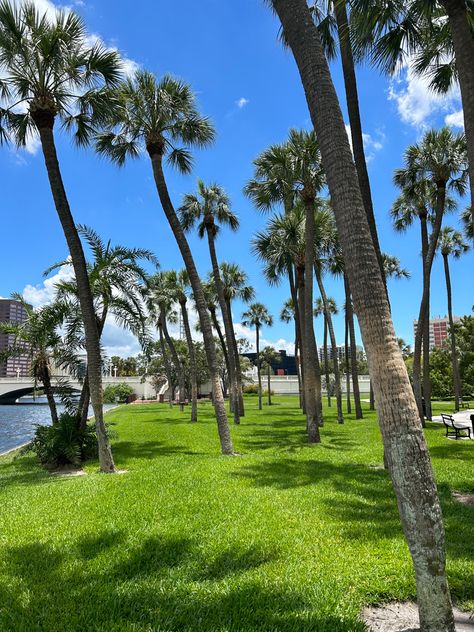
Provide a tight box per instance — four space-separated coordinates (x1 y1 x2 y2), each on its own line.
28 412 97 468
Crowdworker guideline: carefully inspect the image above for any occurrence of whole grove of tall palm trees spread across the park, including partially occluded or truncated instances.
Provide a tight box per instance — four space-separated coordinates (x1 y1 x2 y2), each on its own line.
0 0 474 632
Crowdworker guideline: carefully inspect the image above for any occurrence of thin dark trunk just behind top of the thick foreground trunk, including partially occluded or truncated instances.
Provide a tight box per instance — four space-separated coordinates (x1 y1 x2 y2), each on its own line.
334 1 385 278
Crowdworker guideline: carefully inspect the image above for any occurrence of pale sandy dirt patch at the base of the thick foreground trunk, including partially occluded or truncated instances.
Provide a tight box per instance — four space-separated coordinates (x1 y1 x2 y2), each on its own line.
362 602 474 632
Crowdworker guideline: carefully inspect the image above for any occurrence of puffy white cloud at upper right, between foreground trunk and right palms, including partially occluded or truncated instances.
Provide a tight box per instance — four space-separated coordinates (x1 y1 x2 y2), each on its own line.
388 62 460 128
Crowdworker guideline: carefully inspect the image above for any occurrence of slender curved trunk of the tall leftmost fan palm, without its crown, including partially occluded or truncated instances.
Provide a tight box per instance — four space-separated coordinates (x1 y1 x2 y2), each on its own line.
31 119 116 473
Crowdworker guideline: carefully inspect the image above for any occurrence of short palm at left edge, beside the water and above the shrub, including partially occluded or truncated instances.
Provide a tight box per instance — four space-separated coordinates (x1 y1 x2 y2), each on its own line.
0 294 77 425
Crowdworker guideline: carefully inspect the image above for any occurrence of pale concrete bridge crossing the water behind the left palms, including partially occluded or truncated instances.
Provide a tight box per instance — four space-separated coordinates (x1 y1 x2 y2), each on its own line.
0 376 155 405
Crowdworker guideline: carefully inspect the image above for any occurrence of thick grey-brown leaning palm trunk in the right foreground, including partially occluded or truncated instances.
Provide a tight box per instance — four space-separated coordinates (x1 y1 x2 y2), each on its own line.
272 0 454 632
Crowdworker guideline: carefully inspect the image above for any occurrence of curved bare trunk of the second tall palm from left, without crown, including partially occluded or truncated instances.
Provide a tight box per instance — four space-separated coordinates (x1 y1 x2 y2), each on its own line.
148 149 234 455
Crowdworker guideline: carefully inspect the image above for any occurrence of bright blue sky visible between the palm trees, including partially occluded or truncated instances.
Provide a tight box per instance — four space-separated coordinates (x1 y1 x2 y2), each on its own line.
0 0 474 355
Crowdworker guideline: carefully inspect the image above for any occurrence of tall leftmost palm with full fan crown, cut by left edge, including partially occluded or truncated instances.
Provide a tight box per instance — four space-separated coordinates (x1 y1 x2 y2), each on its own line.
0 0 121 472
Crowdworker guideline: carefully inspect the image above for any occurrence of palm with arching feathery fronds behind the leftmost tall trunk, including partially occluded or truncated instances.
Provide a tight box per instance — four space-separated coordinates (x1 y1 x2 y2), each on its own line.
49 225 159 429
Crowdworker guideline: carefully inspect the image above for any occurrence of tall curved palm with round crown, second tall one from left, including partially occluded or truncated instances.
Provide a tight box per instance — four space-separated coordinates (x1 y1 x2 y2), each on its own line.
97 70 233 454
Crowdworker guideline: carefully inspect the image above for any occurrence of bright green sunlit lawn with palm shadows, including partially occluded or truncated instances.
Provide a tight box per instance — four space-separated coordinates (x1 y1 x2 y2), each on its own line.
0 397 474 632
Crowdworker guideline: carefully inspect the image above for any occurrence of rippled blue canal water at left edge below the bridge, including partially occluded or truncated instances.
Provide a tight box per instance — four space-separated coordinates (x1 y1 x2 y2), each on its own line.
0 397 114 454
